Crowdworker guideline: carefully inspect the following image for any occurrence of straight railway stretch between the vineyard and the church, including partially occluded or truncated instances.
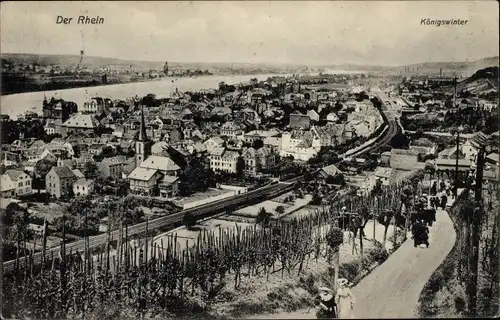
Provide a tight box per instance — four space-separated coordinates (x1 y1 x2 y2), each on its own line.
3 177 301 272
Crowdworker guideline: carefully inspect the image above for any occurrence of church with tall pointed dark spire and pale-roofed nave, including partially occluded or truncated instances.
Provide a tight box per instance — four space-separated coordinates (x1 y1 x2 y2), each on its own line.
128 110 181 198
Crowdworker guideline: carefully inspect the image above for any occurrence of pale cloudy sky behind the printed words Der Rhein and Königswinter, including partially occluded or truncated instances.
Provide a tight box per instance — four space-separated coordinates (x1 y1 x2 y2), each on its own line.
0 0 499 65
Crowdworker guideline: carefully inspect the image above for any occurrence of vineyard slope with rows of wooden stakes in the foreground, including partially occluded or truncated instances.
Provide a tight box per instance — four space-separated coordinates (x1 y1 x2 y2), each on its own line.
2 178 421 319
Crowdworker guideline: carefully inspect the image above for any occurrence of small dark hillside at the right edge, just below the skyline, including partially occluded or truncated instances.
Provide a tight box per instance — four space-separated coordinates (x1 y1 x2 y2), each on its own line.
457 67 498 95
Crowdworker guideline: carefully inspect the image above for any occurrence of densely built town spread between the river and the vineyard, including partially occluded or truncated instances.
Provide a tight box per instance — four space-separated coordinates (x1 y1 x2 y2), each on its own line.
1 67 499 318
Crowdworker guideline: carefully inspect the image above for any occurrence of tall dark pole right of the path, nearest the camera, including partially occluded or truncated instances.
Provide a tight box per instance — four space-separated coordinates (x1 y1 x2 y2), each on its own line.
468 145 485 317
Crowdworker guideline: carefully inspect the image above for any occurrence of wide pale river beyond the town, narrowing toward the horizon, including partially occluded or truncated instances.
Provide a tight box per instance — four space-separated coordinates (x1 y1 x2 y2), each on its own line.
0 74 289 119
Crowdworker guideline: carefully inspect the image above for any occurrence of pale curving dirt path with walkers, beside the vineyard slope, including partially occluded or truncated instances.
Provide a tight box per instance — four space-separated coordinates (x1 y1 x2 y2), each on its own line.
247 204 456 319
